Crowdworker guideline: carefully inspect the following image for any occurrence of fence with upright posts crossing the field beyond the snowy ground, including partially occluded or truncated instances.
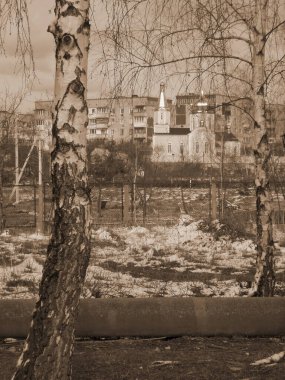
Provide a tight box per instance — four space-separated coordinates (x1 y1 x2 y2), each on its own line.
3 180 285 233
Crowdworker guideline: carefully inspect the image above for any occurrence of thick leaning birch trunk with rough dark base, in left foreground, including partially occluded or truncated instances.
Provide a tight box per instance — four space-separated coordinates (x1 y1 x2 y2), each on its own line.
13 0 90 380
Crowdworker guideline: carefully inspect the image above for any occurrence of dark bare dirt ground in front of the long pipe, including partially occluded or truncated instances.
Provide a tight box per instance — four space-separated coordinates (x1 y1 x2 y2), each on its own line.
0 337 285 380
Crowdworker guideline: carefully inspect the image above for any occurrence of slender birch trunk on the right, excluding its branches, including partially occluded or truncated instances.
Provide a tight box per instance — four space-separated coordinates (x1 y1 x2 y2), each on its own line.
251 0 275 297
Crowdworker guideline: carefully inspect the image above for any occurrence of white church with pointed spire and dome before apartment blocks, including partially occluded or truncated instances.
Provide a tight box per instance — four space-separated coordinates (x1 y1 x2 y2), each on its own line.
152 83 240 165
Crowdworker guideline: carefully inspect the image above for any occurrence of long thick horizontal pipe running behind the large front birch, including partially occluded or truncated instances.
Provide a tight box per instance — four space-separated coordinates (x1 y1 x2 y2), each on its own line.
0 297 285 337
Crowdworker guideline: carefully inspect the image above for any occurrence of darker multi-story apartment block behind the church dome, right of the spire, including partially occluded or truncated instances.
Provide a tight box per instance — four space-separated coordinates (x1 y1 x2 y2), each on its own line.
175 93 285 154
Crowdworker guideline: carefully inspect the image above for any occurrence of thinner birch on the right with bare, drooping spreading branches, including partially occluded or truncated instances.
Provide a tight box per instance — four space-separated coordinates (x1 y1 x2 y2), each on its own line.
101 0 285 296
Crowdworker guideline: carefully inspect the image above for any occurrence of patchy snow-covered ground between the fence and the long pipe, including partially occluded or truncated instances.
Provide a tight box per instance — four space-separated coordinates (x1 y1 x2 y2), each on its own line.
0 216 285 298
